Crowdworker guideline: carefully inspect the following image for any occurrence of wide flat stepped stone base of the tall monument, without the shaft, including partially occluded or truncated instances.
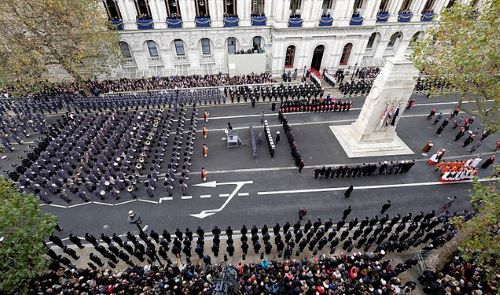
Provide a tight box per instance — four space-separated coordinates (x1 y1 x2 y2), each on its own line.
330 125 414 158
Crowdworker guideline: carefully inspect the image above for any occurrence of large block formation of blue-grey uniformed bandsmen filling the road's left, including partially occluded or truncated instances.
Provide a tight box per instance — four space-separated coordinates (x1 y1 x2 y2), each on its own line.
9 105 197 203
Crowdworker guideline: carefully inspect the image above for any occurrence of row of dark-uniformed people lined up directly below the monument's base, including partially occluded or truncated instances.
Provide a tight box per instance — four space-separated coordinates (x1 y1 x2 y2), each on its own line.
314 160 415 179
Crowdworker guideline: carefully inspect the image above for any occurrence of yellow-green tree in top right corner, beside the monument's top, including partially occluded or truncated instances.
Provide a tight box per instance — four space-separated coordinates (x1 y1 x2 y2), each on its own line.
412 0 500 131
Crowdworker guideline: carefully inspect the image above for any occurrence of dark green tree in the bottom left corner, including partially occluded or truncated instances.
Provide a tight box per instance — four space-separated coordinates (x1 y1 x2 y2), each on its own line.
0 177 57 294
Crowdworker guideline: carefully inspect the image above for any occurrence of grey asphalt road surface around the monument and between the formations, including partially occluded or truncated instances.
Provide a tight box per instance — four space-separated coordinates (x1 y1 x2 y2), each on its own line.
0 91 499 236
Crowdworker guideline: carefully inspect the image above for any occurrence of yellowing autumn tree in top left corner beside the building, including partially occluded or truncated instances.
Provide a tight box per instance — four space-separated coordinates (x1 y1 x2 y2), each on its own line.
0 0 120 94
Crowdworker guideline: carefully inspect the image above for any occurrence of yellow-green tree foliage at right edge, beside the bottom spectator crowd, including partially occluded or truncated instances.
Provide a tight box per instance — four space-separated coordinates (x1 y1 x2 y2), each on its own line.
453 179 500 276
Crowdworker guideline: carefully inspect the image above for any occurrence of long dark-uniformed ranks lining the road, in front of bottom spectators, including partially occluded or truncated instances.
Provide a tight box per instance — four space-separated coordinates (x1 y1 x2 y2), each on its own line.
44 206 473 268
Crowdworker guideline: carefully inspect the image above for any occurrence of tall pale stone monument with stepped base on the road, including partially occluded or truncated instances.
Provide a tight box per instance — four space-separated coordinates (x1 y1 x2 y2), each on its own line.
330 56 418 158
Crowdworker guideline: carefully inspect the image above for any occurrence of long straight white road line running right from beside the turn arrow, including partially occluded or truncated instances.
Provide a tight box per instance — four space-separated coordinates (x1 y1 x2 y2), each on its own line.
257 177 500 196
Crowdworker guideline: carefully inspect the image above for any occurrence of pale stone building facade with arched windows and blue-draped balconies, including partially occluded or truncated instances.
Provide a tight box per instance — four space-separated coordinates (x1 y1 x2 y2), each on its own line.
102 0 481 78
